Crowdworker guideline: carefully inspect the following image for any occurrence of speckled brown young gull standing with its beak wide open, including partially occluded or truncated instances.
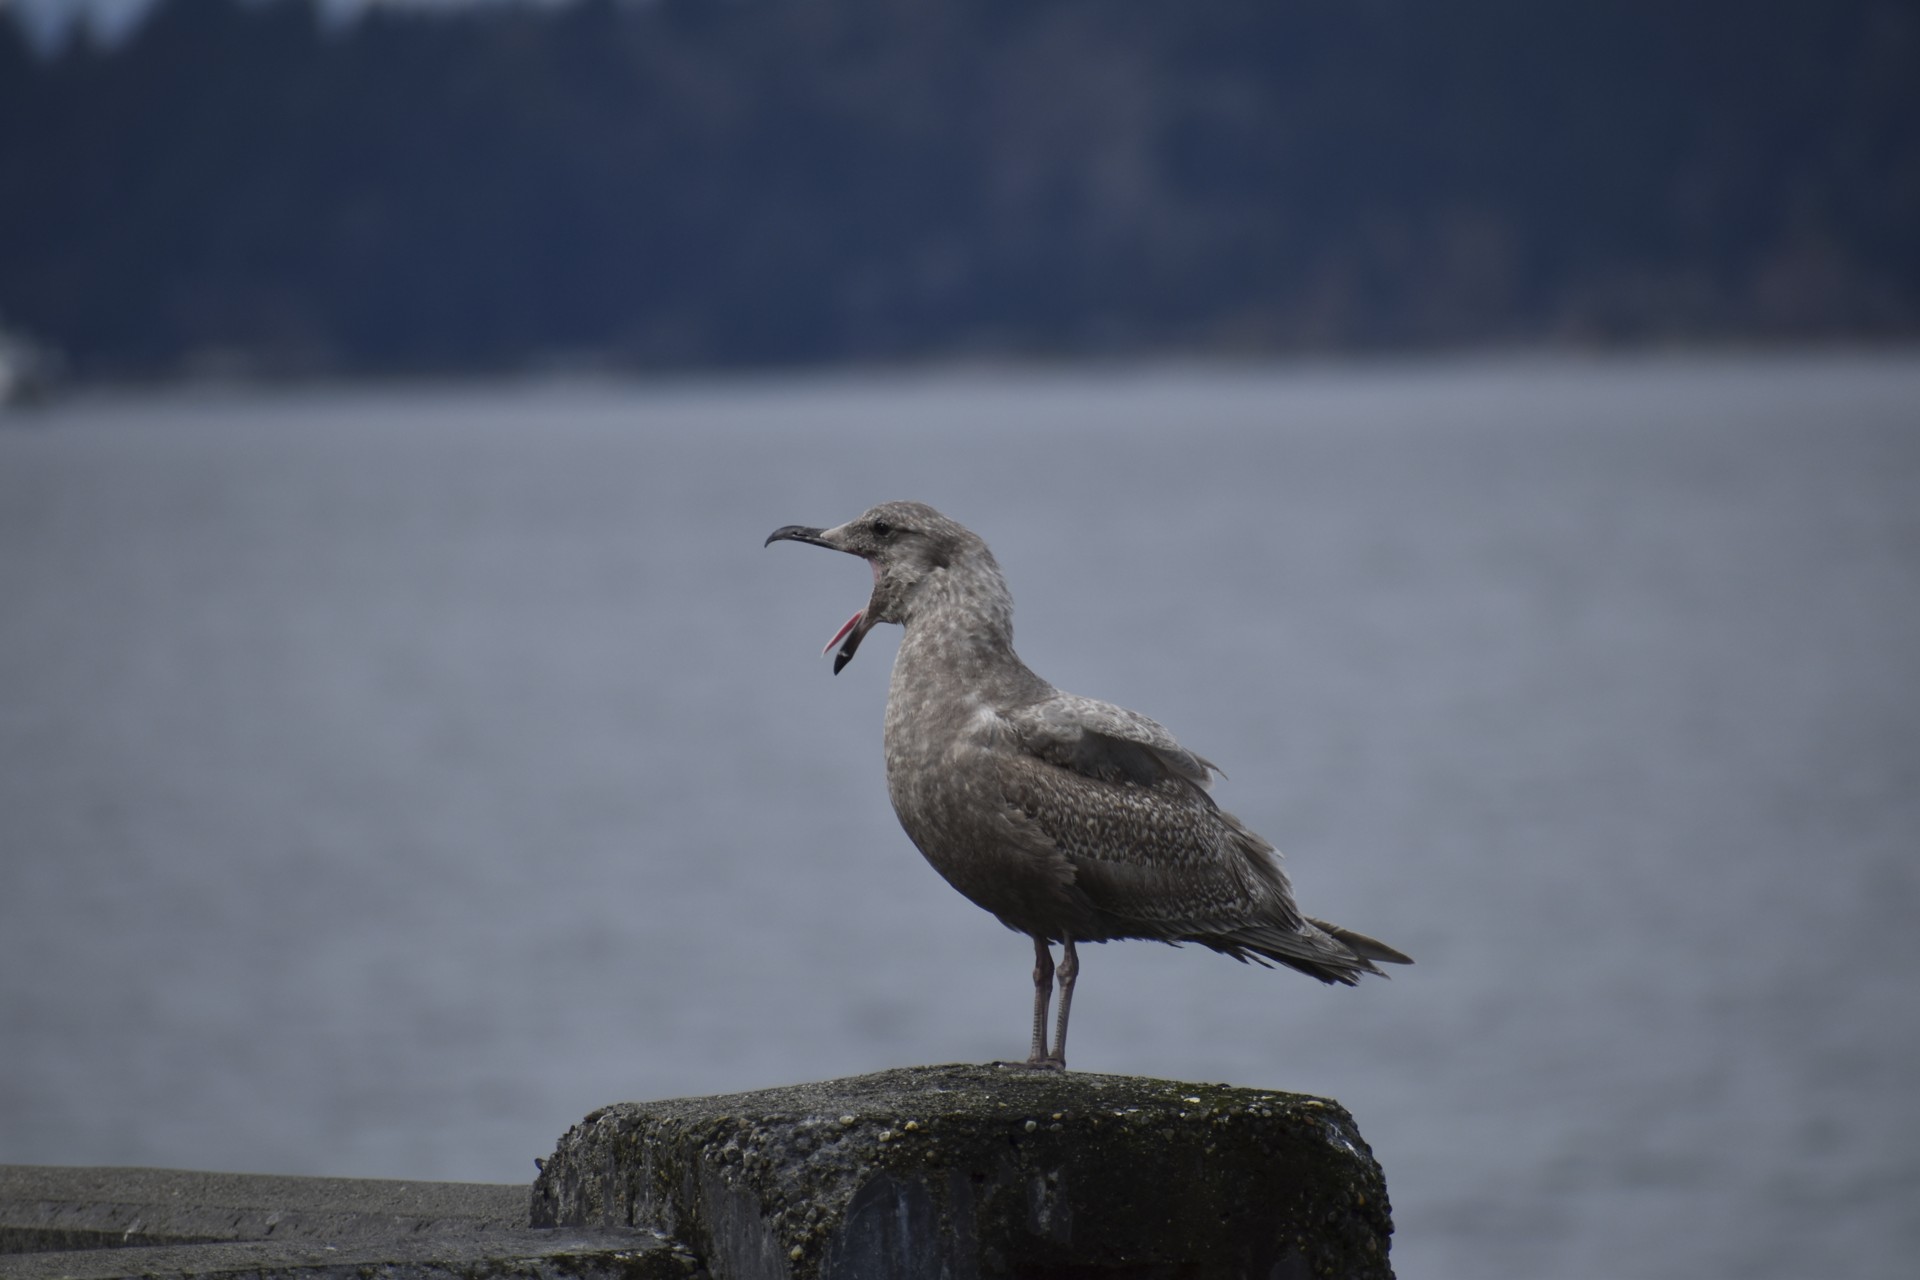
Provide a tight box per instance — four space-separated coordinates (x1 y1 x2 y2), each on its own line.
766 503 1409 1067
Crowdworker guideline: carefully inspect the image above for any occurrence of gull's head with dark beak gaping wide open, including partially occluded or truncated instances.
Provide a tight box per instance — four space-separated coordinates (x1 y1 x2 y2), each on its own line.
764 503 998 676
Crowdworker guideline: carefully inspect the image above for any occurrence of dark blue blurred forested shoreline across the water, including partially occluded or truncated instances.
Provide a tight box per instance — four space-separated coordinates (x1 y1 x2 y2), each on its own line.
0 0 1920 376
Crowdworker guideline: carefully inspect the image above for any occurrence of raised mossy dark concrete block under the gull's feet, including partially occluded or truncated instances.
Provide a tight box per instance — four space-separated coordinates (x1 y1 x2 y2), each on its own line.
532 1067 1392 1280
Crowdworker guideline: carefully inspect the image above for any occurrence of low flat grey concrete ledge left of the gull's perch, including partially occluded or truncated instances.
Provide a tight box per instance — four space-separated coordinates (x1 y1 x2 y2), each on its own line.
0 1165 699 1280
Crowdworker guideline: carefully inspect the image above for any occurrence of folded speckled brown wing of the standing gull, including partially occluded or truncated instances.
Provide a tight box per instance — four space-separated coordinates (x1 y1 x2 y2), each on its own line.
1000 695 1298 936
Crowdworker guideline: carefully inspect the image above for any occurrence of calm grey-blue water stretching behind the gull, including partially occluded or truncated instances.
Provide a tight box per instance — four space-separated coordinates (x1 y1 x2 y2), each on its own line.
0 357 1920 1280
